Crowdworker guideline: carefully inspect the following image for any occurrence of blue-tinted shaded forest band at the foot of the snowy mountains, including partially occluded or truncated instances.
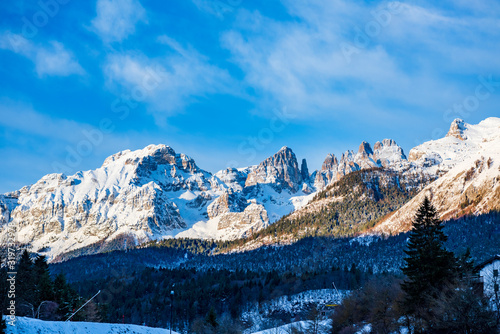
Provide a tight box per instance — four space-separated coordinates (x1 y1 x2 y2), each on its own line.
51 212 500 282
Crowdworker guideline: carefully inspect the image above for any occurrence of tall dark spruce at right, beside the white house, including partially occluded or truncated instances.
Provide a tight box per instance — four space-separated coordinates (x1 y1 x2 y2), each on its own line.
401 197 457 327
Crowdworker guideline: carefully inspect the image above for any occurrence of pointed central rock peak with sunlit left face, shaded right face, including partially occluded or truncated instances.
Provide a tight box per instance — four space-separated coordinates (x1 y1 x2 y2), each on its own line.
245 146 302 192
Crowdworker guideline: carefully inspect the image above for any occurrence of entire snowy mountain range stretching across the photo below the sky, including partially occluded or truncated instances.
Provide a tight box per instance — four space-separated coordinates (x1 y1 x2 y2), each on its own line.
0 118 500 258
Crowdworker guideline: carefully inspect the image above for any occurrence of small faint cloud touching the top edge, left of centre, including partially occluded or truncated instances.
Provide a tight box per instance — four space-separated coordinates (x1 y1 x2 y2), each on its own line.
91 0 146 43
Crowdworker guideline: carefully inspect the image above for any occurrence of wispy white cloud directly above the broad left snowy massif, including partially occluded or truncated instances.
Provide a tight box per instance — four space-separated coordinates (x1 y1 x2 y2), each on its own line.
104 36 236 123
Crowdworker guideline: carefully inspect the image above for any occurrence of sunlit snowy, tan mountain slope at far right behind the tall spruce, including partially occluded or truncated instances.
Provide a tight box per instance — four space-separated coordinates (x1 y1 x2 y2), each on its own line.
373 117 500 233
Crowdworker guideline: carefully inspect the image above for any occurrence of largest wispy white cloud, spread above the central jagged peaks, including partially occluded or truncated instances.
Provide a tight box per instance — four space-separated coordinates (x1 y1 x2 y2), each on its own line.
223 5 412 117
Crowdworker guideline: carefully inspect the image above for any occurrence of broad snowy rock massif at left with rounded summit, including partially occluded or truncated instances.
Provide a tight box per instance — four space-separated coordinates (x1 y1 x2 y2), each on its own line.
3 145 210 254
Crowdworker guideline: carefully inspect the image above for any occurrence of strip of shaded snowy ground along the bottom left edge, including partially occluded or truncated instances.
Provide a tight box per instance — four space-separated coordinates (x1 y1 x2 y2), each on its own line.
3 317 178 334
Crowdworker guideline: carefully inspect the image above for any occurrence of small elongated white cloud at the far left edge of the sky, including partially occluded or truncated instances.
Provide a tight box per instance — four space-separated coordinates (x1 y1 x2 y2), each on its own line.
0 32 85 77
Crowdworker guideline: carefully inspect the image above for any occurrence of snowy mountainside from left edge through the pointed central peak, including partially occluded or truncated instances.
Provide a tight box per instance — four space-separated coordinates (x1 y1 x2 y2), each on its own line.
0 145 311 258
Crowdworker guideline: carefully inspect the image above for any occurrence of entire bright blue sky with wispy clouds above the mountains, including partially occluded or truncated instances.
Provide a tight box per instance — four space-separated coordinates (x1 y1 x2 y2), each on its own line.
0 0 500 193
